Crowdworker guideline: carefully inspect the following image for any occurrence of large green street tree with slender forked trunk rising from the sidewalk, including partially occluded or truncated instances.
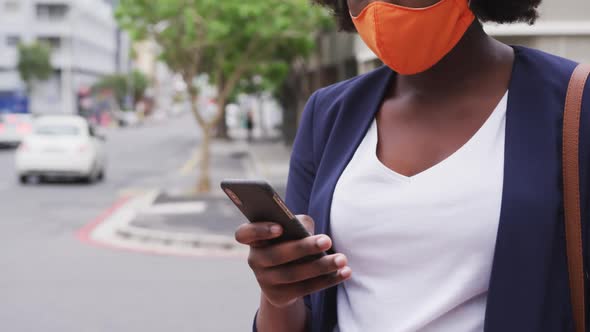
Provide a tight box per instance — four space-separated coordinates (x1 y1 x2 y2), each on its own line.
117 0 327 192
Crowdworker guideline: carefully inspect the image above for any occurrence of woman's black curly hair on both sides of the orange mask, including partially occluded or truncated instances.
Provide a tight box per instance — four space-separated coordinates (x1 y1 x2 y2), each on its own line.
313 0 542 31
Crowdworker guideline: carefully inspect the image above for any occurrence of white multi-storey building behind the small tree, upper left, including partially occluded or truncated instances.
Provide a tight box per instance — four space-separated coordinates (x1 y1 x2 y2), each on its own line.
0 0 129 113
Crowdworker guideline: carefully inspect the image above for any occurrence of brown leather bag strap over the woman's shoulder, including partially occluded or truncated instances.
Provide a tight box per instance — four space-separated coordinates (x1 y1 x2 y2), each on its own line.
563 65 590 332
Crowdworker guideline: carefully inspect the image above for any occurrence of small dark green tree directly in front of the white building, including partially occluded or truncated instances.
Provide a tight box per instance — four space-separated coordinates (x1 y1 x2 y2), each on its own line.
17 43 53 95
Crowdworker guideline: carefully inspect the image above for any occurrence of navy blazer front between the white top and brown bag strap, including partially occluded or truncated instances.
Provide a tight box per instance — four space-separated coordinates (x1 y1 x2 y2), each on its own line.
485 48 580 331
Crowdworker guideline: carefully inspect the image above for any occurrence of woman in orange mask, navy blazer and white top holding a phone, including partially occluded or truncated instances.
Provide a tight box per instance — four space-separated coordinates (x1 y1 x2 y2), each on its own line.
236 0 590 332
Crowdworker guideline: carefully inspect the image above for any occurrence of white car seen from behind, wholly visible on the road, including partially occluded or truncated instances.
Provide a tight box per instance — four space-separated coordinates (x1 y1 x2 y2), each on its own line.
16 115 106 183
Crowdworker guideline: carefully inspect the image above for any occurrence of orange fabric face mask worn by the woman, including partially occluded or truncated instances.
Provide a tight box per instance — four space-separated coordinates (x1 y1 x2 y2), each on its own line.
352 0 475 75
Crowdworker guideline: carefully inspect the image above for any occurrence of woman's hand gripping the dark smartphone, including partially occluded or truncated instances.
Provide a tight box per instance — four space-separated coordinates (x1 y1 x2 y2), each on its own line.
235 215 352 308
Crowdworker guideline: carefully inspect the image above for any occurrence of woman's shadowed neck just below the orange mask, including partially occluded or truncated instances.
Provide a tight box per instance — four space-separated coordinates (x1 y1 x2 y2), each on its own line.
391 21 514 99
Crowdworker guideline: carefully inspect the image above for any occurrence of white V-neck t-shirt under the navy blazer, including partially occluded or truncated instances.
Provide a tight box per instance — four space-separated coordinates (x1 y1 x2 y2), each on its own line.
331 94 508 332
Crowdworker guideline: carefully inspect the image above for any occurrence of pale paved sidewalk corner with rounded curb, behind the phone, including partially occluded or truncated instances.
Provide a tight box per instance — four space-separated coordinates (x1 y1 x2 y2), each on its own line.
83 137 290 256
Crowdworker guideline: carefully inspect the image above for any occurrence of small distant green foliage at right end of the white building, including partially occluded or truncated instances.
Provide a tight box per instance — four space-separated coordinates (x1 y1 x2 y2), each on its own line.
92 70 148 106
